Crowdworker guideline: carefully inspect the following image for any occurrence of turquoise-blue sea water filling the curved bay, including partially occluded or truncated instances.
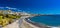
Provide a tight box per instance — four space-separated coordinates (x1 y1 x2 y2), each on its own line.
30 15 60 26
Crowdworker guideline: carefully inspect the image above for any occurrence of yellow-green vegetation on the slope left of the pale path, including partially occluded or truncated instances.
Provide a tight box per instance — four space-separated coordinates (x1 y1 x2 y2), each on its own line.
0 10 21 26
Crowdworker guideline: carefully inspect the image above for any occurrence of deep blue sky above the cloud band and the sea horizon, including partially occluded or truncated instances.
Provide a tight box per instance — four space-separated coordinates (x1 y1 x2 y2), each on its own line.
0 0 60 14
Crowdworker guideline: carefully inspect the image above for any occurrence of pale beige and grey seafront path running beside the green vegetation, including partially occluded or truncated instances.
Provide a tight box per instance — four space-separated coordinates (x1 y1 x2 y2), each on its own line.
3 16 29 28
